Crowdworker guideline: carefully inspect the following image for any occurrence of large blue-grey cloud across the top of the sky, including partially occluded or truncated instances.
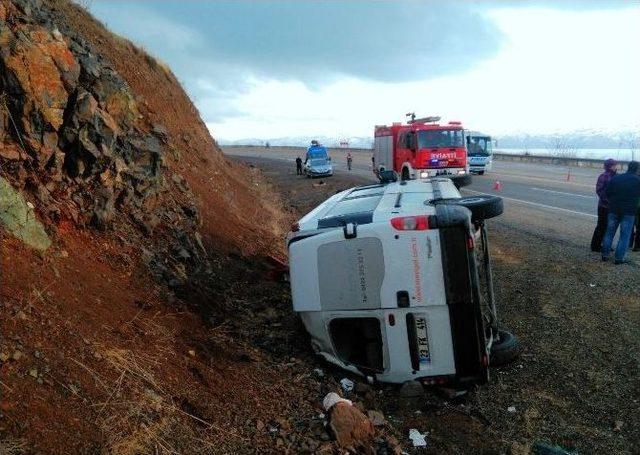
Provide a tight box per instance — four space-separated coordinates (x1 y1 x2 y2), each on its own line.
92 0 501 84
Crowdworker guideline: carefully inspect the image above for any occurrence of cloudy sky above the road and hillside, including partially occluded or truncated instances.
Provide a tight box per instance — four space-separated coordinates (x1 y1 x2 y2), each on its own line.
90 0 640 139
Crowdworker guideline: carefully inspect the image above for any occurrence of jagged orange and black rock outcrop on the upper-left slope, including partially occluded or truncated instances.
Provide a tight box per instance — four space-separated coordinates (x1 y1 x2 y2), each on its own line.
0 0 209 287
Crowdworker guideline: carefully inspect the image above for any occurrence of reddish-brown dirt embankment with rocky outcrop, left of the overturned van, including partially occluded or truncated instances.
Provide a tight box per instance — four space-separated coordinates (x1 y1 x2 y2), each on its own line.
0 0 296 453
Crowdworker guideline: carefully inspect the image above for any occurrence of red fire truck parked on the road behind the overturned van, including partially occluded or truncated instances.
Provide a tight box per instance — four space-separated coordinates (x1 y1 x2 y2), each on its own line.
373 113 469 180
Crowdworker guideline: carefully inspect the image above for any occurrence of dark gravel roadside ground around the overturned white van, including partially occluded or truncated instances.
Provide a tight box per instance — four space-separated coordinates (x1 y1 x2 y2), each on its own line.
235 158 640 453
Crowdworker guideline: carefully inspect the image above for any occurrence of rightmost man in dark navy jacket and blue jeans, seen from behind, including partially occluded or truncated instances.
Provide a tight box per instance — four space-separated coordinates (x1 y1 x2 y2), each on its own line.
602 161 640 264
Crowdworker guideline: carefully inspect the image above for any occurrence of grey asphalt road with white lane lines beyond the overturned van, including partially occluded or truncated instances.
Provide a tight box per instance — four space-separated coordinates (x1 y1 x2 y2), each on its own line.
223 147 616 246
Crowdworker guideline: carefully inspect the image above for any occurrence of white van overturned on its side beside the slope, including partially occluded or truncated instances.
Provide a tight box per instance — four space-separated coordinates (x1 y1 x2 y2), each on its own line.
287 171 517 386
